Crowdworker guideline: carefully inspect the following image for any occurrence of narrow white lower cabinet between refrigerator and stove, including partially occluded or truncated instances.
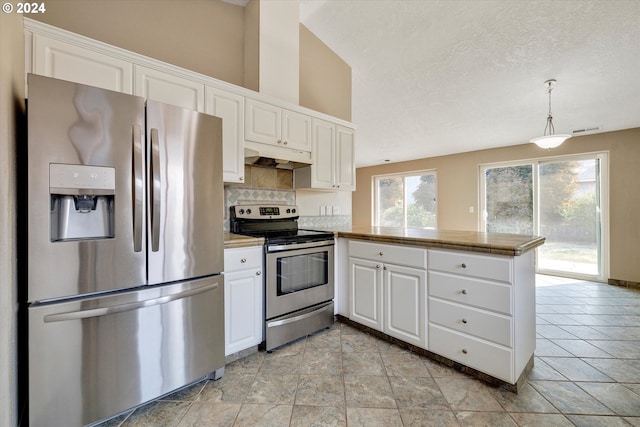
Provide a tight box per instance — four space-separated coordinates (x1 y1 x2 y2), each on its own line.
224 246 264 356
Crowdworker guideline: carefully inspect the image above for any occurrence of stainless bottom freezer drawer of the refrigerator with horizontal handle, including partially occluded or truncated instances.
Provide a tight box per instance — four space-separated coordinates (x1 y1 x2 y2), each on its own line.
29 275 224 427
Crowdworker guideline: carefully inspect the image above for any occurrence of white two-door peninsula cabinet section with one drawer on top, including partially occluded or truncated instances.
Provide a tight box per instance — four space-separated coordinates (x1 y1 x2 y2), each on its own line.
349 241 427 348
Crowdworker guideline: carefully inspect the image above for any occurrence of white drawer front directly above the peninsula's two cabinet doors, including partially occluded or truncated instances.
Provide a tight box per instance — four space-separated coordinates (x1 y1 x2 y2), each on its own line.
349 240 427 269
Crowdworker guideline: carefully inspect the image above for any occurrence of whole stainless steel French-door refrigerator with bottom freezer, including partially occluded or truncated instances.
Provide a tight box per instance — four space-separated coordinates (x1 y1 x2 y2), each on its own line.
25 75 224 427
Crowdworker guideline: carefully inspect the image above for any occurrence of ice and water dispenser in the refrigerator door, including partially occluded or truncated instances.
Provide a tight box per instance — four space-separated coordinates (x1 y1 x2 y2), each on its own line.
49 163 116 242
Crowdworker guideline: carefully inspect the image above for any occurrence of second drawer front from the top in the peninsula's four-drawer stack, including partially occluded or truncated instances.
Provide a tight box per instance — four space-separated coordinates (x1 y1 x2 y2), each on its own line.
428 271 513 315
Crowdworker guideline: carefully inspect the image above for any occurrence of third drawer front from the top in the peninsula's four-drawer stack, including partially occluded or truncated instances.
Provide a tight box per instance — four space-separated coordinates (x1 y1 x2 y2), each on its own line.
427 298 513 347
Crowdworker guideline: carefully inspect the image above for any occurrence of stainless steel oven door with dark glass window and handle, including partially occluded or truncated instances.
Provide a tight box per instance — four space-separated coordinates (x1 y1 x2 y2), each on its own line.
265 240 334 320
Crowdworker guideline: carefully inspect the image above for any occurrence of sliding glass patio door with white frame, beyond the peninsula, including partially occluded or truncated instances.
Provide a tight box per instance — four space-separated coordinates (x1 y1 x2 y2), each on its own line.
481 153 608 280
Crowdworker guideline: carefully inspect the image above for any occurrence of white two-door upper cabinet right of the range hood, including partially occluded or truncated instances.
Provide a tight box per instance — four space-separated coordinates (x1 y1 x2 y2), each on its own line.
294 118 356 191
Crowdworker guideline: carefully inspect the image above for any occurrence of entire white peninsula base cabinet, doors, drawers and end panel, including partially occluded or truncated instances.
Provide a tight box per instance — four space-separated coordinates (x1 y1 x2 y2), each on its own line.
343 239 536 384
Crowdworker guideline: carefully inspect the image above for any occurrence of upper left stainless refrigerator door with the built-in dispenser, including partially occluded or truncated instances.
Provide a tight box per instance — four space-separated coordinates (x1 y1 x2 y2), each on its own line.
25 74 146 301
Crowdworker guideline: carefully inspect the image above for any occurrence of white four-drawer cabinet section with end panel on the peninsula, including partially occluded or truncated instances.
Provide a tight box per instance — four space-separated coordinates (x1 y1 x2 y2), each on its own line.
428 249 535 384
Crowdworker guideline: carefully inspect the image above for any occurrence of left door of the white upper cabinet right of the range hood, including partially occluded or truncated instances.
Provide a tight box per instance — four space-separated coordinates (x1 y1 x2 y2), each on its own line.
311 119 336 189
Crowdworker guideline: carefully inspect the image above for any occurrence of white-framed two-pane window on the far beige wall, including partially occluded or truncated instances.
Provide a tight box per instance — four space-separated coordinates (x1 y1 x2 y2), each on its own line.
373 171 436 228
